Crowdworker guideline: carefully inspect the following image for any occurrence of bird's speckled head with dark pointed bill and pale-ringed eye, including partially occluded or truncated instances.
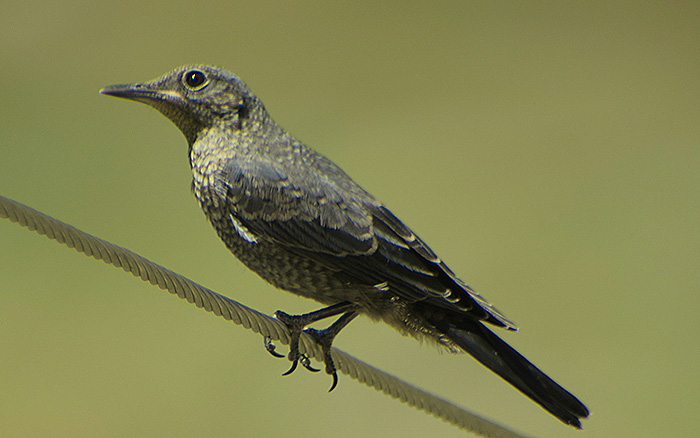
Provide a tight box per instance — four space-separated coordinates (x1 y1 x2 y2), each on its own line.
100 65 264 144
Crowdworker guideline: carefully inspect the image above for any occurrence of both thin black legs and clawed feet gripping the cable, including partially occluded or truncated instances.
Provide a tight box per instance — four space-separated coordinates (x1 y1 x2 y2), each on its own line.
265 302 357 389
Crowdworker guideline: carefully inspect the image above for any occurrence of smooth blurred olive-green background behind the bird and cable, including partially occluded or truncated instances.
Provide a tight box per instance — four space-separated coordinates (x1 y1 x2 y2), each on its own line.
0 1 700 438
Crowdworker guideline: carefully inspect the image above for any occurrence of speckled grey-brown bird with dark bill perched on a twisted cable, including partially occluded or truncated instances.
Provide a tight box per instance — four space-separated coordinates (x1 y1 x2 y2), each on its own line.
100 65 589 429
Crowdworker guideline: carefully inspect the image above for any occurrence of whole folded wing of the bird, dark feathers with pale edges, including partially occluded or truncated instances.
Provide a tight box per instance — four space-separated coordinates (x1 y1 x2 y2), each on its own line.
220 160 515 329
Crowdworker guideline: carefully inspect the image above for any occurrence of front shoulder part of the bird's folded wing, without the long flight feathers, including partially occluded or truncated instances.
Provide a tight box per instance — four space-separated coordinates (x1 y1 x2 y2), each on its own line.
218 160 377 257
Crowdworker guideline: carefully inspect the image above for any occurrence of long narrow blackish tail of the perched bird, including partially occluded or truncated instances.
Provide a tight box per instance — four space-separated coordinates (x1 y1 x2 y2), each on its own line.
424 312 589 429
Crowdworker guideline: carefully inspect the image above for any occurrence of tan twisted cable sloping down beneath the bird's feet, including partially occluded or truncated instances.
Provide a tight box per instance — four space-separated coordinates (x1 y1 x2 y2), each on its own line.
0 196 525 438
